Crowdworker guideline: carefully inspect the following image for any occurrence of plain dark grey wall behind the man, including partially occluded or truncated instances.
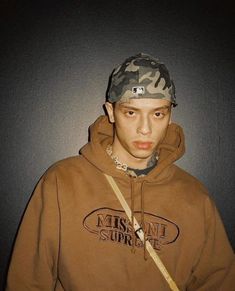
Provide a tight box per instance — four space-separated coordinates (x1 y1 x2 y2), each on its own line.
0 0 235 289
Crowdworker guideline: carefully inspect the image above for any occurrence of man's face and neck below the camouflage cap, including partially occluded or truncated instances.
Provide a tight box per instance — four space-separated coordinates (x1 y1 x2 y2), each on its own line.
105 98 171 169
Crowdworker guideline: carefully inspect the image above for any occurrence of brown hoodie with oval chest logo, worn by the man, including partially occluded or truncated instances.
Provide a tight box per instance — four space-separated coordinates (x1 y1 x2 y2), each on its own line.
7 116 235 291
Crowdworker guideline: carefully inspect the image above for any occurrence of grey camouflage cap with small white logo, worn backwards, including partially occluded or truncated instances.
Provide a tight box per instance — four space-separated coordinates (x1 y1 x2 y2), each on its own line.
107 53 177 106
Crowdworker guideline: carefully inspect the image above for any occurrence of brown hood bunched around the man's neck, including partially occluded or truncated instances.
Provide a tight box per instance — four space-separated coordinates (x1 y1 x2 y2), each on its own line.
80 116 185 181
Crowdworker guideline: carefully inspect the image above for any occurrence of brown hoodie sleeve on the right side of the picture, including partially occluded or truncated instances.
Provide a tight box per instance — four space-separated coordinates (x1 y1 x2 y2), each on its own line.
187 197 235 291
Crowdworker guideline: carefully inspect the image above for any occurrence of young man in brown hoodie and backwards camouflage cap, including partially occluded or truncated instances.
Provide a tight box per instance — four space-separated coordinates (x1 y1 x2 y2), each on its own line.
7 54 235 291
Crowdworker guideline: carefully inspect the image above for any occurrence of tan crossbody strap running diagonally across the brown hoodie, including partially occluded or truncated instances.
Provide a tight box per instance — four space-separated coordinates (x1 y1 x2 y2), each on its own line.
104 174 180 291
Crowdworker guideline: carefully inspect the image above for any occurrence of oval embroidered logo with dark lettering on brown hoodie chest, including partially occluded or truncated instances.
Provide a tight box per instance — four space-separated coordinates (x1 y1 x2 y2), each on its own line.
83 207 180 251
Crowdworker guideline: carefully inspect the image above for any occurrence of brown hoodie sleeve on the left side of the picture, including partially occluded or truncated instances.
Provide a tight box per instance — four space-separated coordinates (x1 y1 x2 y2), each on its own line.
6 173 60 291
